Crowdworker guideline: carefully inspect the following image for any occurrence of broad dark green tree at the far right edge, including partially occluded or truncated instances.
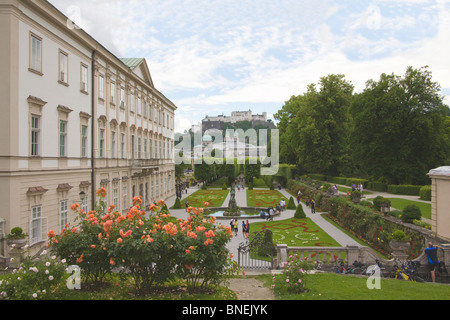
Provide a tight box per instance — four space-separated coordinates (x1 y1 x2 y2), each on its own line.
350 67 449 184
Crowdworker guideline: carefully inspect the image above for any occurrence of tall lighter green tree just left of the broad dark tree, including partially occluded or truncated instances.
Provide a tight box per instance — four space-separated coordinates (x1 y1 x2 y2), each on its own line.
295 74 353 175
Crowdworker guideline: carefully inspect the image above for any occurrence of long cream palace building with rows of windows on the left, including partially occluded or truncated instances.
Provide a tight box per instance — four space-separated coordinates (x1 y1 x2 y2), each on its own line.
0 0 177 257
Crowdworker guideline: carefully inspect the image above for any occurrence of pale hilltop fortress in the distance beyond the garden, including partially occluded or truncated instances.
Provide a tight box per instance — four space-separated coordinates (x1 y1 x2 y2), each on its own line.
202 110 275 132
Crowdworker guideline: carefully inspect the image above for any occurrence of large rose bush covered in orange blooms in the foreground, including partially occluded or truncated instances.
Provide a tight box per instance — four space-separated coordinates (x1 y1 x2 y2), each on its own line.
49 188 232 292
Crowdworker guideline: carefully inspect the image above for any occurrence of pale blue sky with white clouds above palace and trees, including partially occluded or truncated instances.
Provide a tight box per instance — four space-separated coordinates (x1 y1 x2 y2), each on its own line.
49 0 450 132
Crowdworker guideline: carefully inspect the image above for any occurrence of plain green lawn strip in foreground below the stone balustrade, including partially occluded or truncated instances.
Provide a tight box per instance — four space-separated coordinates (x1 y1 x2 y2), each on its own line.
257 273 450 300
